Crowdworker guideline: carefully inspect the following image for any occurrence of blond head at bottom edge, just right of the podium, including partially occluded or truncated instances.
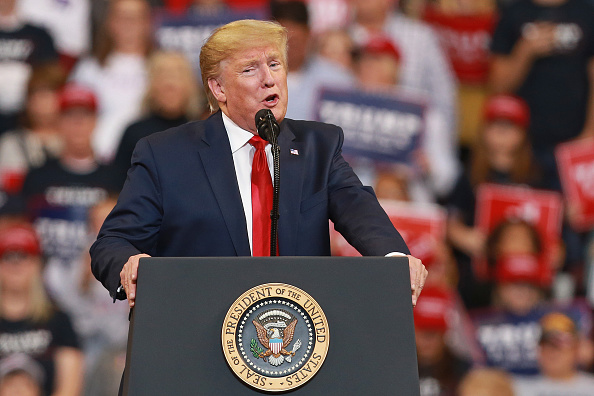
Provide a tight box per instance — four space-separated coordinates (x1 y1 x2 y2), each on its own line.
458 368 512 396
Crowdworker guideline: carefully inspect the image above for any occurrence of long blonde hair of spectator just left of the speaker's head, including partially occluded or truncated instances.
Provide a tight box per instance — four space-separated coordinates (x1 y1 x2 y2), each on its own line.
142 51 203 120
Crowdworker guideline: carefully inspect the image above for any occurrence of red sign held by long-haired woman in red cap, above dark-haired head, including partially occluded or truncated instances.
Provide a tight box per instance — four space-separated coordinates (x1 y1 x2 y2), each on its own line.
475 183 563 277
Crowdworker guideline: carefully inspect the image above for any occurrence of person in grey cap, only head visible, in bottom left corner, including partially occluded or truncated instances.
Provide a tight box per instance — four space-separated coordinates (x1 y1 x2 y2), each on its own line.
0 354 45 396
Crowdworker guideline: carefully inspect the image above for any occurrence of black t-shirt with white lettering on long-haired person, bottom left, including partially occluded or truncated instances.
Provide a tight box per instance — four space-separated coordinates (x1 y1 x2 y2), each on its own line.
0 311 80 395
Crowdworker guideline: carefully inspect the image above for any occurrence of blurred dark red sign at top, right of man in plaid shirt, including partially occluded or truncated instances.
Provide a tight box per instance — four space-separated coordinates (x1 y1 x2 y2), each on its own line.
425 7 497 83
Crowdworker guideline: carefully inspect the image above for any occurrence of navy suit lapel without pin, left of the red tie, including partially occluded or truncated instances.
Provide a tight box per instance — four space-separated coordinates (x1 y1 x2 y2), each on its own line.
198 111 251 256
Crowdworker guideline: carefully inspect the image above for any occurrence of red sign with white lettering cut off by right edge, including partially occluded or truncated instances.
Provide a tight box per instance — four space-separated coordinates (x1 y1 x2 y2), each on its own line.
555 139 594 231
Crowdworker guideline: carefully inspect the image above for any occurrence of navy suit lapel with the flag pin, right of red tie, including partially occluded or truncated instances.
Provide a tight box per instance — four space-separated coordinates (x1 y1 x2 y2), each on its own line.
278 121 305 256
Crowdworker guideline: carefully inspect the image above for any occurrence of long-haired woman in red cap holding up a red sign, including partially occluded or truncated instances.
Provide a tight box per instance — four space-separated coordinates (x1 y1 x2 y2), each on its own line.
447 95 538 308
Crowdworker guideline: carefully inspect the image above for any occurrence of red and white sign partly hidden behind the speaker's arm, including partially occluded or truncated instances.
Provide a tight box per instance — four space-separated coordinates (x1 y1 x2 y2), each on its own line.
330 200 446 265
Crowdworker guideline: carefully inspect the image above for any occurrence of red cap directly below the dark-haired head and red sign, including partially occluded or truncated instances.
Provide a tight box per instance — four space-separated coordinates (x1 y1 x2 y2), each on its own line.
495 254 546 286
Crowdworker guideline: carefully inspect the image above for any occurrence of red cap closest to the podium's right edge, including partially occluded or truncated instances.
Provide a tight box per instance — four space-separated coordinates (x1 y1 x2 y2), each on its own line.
413 286 453 332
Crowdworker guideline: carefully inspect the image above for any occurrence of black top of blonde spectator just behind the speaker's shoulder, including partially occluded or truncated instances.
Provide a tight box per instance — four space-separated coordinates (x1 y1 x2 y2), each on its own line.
112 113 188 188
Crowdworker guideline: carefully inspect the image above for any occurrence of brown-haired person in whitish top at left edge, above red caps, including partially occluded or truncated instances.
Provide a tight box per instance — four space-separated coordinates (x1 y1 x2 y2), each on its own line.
0 65 66 194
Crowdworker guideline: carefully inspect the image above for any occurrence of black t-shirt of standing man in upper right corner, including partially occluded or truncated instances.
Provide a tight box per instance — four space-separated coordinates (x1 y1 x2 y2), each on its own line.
491 0 594 149
